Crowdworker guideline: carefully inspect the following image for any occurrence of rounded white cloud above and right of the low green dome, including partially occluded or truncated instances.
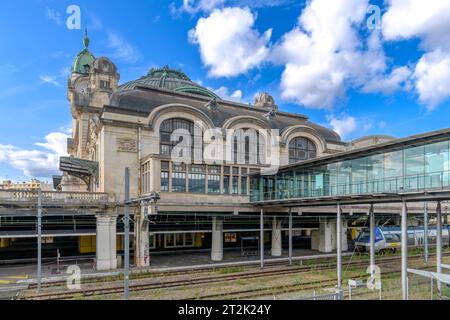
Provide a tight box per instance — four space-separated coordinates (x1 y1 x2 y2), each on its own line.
189 7 272 77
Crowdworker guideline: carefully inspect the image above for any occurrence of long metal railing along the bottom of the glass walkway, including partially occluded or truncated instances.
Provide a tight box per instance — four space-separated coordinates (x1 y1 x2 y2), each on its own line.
250 171 450 202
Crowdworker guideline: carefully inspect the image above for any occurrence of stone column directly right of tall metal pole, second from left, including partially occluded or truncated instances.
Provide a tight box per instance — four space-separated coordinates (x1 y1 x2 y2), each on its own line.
134 205 150 268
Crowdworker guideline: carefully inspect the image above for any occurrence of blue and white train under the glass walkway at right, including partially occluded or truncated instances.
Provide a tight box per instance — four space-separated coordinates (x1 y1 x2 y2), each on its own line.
355 226 450 252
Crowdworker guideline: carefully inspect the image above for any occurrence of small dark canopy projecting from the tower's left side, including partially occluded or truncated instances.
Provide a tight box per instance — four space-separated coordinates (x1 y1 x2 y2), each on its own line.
59 157 99 186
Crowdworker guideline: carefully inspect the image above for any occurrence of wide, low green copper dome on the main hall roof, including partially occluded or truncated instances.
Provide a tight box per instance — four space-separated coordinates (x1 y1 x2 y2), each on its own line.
119 66 220 100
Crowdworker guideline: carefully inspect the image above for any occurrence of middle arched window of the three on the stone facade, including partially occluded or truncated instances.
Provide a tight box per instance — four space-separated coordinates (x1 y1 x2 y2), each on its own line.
233 129 266 164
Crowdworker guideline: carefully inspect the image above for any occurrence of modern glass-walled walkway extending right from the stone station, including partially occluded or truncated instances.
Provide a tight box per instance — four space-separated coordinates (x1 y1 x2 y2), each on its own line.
251 133 450 202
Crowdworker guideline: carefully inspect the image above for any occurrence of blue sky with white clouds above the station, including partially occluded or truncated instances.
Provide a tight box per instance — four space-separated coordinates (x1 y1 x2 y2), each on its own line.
0 0 450 180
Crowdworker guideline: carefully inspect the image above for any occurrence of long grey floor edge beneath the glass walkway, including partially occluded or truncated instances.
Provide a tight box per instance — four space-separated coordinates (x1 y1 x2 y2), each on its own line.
253 189 450 208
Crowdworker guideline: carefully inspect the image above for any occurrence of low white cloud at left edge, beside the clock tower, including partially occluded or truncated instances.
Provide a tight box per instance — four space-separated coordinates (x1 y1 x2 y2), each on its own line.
0 132 69 178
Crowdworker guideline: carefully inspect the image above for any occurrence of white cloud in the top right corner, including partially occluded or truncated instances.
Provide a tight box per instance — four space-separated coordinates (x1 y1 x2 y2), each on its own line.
382 0 450 110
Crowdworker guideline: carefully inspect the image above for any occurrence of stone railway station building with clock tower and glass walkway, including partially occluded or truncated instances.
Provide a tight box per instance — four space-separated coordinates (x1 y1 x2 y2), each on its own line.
0 35 450 270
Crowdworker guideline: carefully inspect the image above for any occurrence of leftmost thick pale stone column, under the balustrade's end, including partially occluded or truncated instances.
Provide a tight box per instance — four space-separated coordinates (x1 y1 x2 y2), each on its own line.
96 215 117 271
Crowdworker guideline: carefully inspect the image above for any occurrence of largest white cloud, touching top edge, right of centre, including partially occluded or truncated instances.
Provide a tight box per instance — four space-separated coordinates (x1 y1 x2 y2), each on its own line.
271 0 394 108
